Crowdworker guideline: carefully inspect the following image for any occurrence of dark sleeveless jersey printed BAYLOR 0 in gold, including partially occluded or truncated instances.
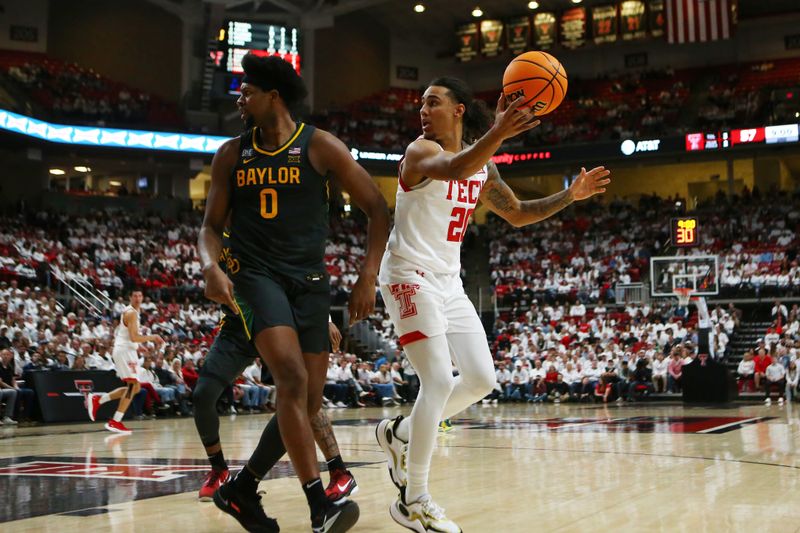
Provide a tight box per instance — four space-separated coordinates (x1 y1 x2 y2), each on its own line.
230 122 328 279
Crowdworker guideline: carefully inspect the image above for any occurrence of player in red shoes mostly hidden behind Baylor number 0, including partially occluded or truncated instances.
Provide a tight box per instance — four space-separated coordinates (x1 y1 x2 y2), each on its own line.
192 233 358 504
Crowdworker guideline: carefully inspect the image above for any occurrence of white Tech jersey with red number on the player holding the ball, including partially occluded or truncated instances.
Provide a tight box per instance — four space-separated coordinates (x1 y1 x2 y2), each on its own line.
384 150 488 274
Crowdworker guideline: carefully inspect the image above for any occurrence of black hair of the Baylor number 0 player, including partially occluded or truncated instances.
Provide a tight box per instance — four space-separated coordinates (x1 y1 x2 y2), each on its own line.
242 53 308 115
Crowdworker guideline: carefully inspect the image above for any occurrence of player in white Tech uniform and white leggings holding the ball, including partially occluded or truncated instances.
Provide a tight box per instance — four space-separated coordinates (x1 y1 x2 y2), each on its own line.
376 78 610 533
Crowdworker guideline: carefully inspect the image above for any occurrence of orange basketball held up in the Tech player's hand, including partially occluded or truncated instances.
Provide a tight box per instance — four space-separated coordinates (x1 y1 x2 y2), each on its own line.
503 52 567 116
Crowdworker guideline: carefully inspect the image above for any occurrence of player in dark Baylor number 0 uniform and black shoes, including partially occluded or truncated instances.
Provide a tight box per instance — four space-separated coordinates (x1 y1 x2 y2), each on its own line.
198 55 389 532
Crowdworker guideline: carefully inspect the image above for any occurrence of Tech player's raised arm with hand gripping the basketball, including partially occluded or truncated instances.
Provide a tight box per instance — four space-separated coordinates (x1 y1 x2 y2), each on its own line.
403 94 540 186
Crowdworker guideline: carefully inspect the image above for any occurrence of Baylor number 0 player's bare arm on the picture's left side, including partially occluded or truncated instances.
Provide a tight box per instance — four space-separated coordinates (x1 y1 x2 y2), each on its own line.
197 138 239 312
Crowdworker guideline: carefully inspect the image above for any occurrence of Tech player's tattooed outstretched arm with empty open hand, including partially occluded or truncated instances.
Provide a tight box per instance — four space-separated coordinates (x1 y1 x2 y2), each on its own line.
480 163 611 227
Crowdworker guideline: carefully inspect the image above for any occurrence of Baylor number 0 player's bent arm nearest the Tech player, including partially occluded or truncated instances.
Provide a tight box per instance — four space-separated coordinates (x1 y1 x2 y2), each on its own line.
309 129 389 324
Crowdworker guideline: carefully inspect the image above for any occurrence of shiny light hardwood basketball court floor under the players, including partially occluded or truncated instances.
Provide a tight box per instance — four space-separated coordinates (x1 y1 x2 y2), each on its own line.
0 403 800 533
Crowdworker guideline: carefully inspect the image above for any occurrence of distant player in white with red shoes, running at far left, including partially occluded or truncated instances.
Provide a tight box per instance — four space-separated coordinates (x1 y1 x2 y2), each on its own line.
86 291 164 435
